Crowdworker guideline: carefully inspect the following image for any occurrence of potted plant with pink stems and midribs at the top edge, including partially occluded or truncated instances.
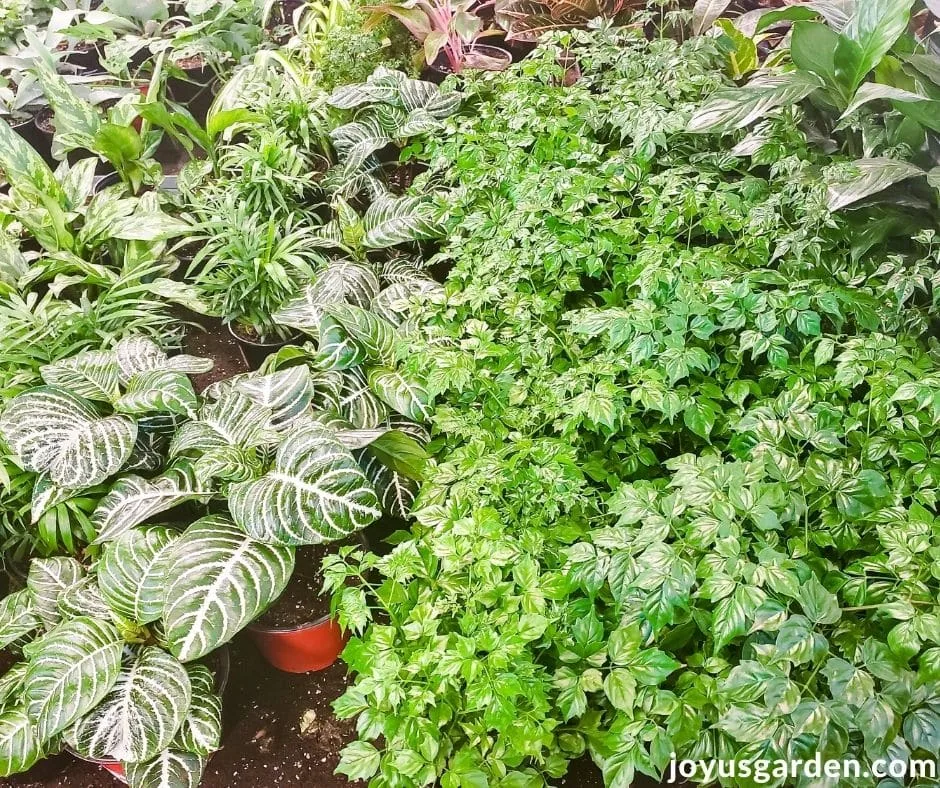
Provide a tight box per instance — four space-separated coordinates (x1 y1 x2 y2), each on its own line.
365 0 512 78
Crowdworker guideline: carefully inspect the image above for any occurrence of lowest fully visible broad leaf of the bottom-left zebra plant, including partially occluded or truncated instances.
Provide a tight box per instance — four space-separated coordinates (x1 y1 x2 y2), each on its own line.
71 646 192 762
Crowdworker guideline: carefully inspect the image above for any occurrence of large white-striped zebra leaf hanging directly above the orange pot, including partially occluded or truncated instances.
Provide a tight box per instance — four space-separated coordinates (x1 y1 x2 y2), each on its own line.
229 423 381 545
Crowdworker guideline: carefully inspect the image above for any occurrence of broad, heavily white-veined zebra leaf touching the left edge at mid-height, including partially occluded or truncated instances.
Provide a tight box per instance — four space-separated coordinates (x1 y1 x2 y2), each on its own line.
0 386 137 489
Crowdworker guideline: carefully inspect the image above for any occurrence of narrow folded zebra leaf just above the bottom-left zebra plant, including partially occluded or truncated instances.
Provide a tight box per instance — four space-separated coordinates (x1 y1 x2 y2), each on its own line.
91 460 205 544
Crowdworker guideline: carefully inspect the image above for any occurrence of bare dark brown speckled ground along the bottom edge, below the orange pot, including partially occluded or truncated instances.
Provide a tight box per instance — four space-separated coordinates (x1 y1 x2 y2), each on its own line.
11 638 363 788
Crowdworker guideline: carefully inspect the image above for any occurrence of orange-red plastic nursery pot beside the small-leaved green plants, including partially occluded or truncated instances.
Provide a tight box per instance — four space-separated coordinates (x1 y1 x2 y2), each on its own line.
247 533 369 673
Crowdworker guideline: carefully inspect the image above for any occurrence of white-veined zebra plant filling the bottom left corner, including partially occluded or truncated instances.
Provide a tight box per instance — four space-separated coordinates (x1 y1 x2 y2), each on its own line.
0 510 294 788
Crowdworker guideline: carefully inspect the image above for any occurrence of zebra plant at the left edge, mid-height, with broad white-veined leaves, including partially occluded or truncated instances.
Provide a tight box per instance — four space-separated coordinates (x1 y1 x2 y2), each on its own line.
0 337 212 522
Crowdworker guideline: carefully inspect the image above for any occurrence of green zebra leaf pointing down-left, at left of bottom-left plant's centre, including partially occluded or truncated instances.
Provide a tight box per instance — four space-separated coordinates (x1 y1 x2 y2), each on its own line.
23 617 124 741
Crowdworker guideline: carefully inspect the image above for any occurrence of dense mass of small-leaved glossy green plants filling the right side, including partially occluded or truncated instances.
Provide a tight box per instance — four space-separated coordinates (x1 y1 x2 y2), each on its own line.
331 24 940 788
